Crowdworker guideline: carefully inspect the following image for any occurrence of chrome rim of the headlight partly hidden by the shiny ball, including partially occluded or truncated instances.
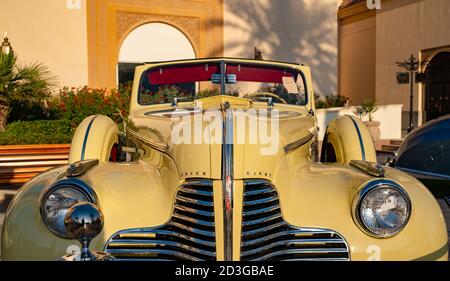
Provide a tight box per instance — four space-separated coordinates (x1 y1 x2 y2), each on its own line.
40 178 97 236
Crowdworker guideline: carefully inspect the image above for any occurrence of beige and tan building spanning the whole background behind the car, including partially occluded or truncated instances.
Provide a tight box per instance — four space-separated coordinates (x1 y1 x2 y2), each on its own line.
0 0 450 135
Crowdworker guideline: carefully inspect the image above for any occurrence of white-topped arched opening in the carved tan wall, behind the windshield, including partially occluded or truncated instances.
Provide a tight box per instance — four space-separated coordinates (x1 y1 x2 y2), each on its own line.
117 23 196 83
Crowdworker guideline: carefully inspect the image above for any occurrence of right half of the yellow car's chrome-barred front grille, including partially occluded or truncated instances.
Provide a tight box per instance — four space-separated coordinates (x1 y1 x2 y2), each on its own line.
241 180 350 261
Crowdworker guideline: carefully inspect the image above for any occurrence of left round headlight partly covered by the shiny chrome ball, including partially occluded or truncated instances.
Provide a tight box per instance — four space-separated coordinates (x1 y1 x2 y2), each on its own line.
41 180 93 238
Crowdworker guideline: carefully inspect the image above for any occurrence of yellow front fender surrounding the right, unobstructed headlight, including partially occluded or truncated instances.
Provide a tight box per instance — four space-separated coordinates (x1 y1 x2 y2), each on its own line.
274 159 448 260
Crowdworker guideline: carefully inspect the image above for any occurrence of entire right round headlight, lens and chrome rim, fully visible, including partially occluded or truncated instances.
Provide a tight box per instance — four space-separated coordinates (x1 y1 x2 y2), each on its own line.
354 180 411 238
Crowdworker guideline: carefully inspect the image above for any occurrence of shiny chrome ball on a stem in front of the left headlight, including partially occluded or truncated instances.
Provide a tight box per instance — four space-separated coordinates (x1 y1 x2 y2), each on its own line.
60 202 114 261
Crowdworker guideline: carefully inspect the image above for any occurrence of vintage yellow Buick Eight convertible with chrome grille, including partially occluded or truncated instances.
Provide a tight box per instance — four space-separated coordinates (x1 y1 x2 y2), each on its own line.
1 58 448 261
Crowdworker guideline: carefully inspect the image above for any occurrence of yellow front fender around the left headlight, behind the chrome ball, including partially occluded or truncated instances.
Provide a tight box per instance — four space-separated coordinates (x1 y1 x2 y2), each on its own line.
1 154 180 260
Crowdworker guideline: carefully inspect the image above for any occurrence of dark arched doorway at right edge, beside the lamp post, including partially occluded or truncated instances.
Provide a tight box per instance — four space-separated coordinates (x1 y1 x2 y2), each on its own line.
425 52 450 121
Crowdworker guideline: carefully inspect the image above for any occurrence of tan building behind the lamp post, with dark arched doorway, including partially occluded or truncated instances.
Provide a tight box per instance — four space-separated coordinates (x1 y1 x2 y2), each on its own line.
338 0 450 132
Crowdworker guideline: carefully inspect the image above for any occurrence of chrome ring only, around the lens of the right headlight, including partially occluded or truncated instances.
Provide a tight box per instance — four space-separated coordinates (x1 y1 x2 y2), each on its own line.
352 179 412 239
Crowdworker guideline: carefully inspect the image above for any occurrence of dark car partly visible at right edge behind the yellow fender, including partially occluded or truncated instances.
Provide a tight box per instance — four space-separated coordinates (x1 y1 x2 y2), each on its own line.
391 115 450 205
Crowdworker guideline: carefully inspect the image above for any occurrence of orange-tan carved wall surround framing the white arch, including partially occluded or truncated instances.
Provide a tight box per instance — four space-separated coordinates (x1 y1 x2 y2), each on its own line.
86 0 224 88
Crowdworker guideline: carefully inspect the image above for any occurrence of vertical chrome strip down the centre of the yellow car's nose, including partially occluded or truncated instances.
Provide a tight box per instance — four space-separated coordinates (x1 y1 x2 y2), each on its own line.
222 102 234 261
